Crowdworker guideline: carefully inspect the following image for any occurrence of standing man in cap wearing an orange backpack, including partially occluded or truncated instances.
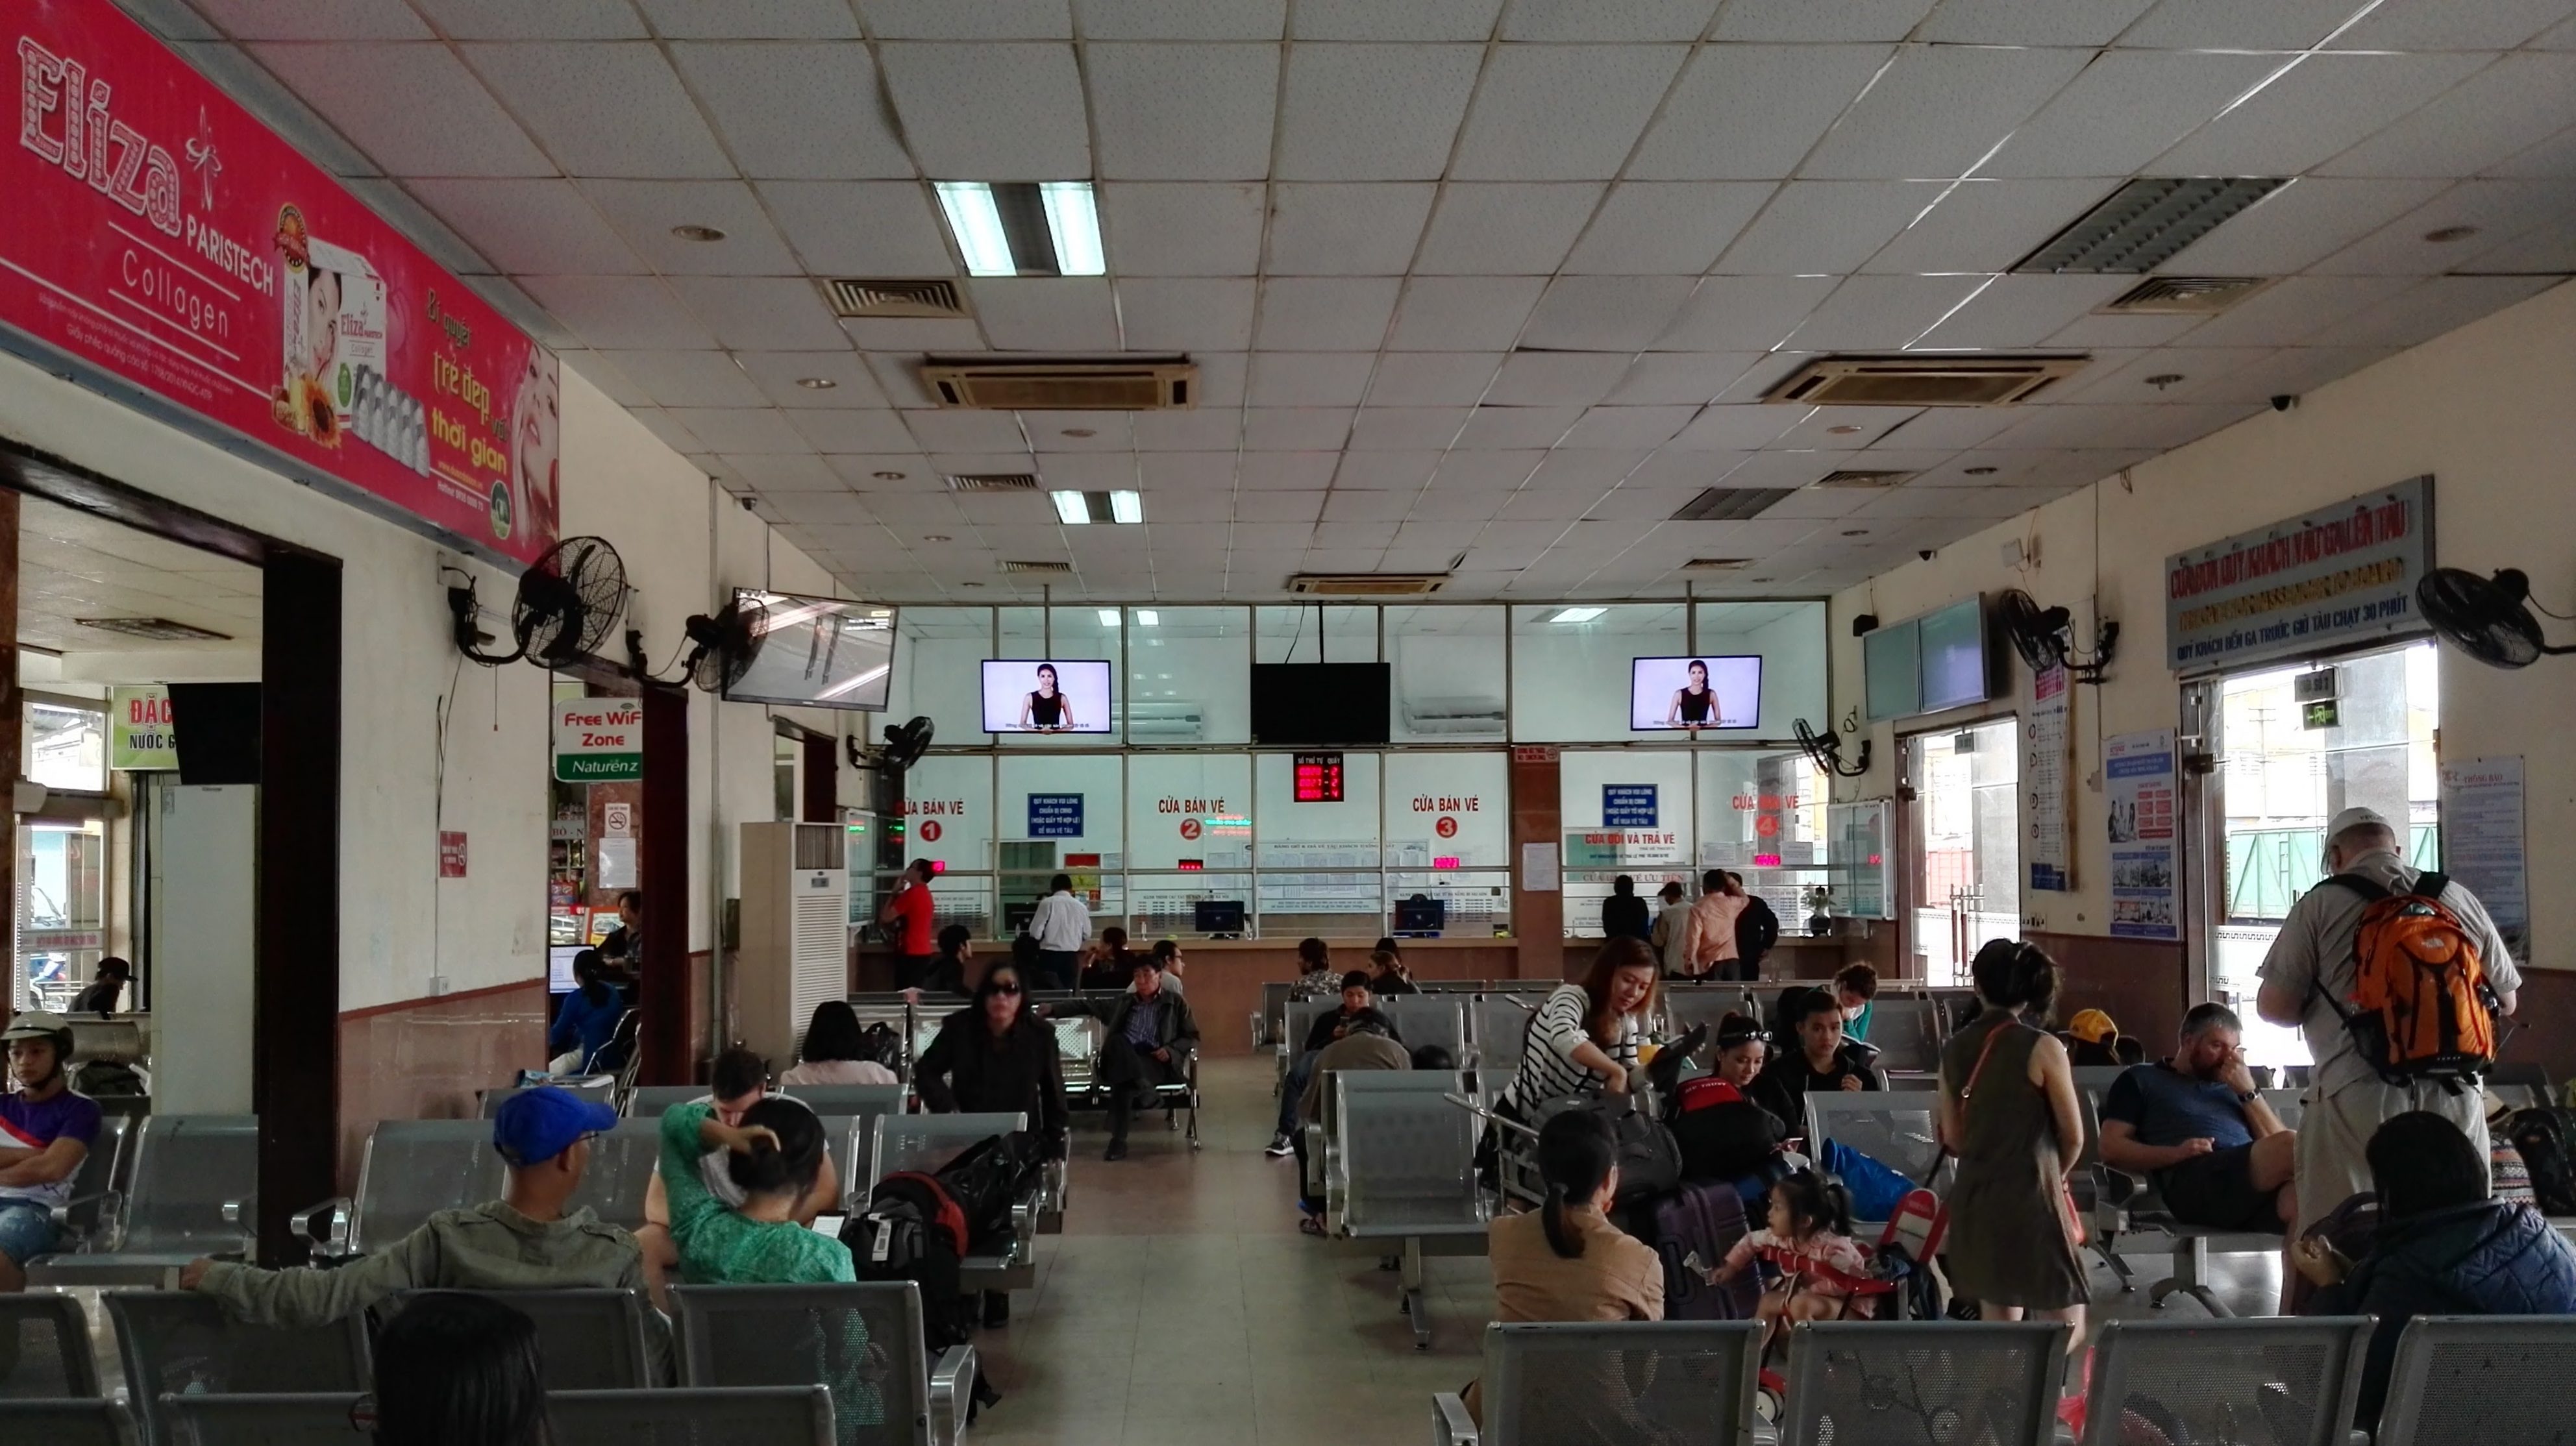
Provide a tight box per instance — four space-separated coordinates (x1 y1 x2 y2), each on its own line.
2254 809 2522 1237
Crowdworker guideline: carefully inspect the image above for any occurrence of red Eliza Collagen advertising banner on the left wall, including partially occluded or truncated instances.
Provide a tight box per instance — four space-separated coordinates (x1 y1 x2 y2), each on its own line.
0 0 562 562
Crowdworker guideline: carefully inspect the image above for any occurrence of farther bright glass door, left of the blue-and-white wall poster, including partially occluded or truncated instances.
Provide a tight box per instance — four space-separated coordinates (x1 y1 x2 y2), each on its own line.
1903 719 2022 985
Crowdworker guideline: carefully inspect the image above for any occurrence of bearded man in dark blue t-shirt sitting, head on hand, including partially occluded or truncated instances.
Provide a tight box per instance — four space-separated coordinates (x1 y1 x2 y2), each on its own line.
2102 1005 2297 1232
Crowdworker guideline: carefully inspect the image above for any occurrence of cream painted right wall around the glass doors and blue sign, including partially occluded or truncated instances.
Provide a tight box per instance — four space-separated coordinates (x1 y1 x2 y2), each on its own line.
1829 275 2576 969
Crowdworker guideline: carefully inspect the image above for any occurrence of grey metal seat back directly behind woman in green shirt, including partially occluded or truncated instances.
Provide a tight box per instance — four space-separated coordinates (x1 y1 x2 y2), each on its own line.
670 1281 976 1446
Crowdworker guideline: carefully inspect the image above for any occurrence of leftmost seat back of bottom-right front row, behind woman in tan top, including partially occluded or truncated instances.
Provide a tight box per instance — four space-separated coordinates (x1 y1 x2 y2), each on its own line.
1432 1319 1772 1446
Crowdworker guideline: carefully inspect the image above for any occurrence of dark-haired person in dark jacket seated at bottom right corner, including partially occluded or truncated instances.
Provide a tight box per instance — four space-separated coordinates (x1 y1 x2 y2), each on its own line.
2290 1111 2576 1430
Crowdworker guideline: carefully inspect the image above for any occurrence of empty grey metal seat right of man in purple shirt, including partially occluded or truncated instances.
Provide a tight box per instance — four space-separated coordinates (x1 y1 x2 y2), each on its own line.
26 1114 260 1286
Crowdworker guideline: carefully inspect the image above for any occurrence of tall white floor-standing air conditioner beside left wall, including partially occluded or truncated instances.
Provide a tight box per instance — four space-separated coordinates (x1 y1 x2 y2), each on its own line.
734 822 850 1070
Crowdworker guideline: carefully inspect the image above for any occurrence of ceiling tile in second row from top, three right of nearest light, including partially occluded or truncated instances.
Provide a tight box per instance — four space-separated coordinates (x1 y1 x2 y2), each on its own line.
1450 46 1690 180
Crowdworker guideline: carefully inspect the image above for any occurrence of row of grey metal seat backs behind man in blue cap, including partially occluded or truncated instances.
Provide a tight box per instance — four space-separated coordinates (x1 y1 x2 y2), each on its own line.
0 1281 976 1446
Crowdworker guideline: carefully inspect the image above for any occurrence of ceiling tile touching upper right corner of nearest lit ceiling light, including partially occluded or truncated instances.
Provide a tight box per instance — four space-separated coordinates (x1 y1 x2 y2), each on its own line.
1082 44 1280 180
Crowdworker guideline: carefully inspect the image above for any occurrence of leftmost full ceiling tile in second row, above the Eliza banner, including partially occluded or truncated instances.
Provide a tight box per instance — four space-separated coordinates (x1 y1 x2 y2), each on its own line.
250 42 554 175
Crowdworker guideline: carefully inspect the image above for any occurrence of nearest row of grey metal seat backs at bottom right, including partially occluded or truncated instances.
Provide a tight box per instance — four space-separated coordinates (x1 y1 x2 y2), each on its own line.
1432 1317 2576 1446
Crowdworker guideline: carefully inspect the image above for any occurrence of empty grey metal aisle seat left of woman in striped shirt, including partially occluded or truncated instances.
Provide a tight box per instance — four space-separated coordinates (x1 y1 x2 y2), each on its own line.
1327 1070 1491 1351
